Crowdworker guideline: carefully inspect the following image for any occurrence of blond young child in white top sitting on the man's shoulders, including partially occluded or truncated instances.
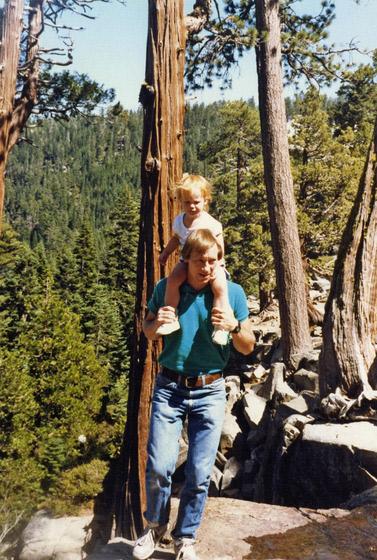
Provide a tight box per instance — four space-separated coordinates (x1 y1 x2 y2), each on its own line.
156 173 229 345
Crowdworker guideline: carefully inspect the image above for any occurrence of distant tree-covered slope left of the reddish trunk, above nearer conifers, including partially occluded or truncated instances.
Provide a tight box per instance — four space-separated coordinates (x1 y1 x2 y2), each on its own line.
5 110 142 256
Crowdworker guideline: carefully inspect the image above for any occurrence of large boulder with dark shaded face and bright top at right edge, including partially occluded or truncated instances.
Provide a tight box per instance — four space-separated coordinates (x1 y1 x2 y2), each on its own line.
282 422 377 507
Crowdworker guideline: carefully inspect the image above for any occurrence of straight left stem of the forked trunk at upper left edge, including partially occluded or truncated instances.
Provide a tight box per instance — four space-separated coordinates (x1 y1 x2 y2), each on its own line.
0 0 24 229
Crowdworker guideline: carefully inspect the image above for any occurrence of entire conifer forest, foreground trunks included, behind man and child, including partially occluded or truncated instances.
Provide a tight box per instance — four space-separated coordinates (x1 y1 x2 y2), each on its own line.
0 0 377 543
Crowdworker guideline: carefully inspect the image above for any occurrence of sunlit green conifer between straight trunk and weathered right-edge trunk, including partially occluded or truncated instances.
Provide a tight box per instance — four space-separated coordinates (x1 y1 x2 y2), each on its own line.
291 88 364 258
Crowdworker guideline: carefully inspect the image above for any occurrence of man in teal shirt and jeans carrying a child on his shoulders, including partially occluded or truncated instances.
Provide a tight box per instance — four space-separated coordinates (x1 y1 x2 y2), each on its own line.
133 229 255 560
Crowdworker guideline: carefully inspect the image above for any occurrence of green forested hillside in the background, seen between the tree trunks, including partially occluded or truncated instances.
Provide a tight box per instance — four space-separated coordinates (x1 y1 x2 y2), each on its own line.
0 77 374 523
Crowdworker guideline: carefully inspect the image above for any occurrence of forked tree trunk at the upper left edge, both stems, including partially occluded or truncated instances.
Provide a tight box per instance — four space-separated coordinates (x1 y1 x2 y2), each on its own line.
0 0 43 227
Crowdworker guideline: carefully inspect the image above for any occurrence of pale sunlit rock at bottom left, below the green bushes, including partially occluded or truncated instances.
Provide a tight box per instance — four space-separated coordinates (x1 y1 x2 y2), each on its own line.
19 511 92 560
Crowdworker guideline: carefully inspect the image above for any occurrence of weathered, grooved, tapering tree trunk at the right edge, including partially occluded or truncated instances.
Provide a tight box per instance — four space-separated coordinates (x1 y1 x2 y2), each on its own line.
320 120 377 397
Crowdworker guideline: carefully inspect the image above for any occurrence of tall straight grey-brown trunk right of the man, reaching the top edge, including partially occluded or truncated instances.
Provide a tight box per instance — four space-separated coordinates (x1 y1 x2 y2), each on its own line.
256 0 311 369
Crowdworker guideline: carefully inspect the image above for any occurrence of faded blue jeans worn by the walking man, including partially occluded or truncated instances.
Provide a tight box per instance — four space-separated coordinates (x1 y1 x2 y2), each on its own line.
145 374 225 539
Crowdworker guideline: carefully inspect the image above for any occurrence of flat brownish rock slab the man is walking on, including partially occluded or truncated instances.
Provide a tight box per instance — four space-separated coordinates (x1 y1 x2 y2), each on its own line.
88 498 377 560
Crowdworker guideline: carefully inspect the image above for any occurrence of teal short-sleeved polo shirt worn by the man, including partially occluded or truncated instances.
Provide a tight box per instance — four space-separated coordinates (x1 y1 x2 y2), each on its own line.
148 278 249 376
